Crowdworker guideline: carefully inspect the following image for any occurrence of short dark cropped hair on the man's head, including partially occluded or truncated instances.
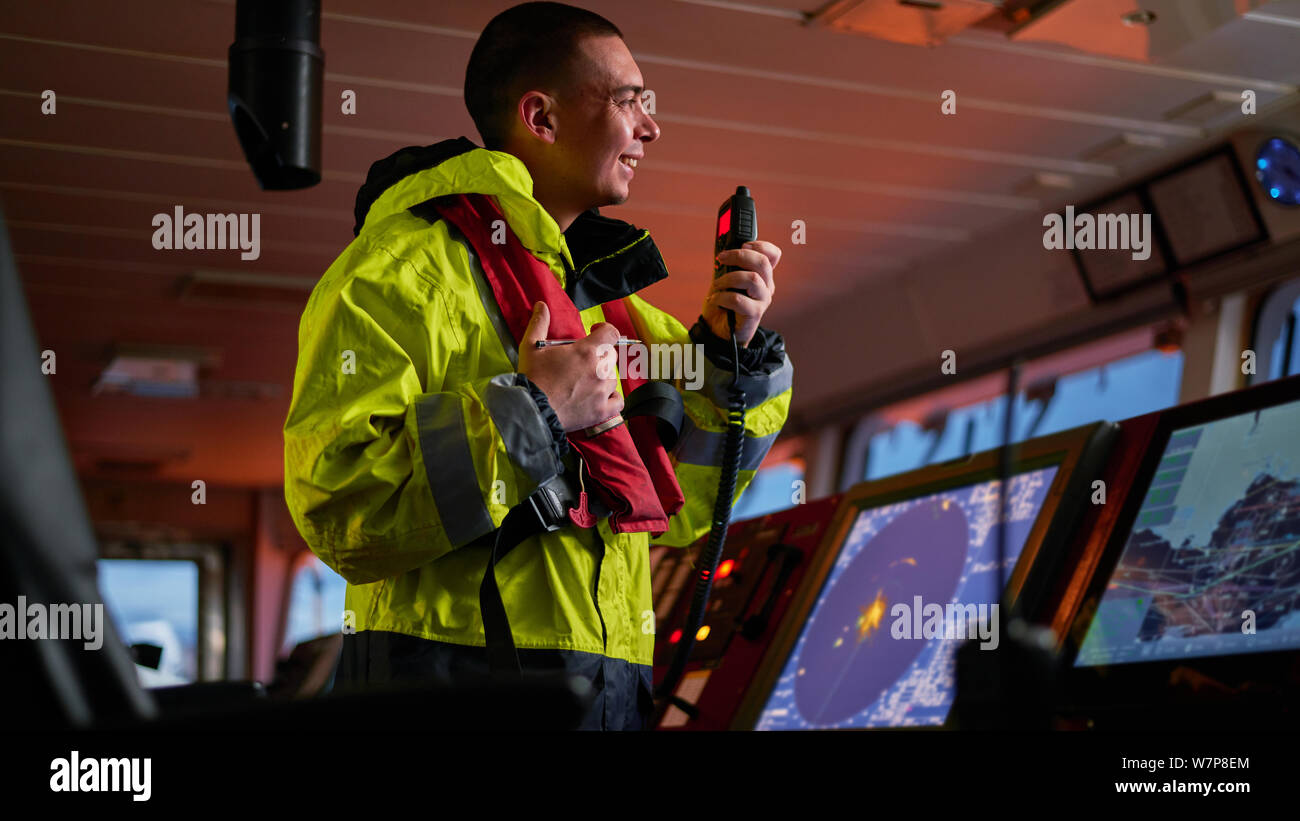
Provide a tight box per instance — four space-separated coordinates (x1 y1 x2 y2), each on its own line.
465 3 623 151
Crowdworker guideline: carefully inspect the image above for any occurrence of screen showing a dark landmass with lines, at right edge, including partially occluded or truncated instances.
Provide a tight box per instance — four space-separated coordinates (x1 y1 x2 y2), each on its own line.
1074 401 1300 666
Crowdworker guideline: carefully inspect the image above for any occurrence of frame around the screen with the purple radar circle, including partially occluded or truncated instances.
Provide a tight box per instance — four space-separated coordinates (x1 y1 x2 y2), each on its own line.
732 422 1115 730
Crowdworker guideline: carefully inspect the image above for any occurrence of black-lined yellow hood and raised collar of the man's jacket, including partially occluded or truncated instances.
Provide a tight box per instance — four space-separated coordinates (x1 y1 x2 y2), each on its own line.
352 136 668 310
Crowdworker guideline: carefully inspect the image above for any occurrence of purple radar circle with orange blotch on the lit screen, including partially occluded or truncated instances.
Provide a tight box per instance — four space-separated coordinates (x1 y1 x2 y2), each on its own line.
794 499 970 725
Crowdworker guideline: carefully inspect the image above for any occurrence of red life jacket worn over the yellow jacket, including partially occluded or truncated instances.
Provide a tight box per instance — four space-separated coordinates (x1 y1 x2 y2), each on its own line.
429 194 684 535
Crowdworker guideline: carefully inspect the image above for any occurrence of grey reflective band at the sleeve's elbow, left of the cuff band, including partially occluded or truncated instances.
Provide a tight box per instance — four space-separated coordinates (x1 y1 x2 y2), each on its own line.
415 394 493 547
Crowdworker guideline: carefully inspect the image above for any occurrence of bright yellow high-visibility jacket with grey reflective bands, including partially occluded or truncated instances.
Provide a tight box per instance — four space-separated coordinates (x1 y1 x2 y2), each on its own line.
285 138 792 711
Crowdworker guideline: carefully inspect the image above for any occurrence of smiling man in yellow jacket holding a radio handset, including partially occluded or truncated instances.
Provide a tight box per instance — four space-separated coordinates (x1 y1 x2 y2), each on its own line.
285 3 792 729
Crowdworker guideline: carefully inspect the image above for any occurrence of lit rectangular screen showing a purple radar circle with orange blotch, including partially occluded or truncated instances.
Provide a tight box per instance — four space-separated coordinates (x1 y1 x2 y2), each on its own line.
757 466 1058 730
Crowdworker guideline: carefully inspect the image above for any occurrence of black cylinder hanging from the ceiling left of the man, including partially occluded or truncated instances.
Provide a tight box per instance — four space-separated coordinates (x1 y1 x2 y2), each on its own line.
228 0 325 191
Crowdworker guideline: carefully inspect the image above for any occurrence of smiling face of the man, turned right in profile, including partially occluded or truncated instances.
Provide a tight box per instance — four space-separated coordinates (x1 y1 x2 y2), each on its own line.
547 36 659 210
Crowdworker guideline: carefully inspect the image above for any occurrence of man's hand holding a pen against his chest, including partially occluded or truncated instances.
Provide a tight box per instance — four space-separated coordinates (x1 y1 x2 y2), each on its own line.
519 303 623 433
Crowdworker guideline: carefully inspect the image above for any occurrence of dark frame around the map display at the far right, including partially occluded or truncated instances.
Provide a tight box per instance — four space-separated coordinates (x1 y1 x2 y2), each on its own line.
1062 375 1300 713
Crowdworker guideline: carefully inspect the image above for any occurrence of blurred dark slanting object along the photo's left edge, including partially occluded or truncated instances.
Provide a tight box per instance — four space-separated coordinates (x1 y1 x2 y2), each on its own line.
0 206 157 729
